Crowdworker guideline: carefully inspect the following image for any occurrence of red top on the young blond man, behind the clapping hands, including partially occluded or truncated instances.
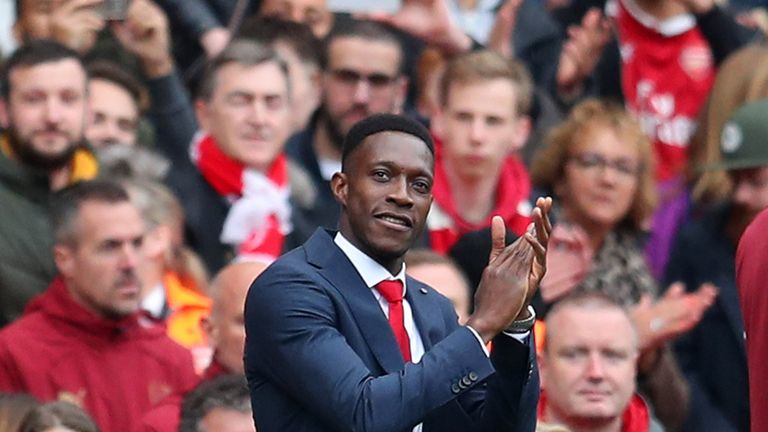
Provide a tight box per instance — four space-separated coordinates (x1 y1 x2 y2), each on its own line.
428 139 531 253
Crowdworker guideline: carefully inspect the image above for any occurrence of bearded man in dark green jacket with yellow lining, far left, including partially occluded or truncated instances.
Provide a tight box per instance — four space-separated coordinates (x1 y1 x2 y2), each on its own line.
0 41 98 326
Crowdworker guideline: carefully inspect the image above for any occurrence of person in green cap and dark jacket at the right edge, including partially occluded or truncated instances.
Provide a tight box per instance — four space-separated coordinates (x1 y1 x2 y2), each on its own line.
667 100 768 432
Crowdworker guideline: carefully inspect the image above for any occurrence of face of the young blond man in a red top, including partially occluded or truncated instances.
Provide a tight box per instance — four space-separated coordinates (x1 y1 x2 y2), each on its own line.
436 79 530 182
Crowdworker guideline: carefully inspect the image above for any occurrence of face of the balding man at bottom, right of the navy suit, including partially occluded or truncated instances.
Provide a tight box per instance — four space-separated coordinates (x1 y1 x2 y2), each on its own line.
540 306 637 424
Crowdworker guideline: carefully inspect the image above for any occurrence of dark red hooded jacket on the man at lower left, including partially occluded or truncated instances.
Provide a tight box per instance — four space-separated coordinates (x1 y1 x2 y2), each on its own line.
0 278 198 432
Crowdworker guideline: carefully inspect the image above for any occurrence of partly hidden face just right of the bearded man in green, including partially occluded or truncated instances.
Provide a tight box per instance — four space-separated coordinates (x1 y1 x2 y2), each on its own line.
85 78 139 147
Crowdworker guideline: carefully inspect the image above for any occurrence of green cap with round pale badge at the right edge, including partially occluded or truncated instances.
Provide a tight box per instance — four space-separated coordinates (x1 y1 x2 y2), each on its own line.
704 99 768 170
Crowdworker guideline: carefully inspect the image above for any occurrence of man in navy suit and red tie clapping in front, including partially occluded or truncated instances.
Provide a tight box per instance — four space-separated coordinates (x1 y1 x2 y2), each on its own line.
245 114 551 432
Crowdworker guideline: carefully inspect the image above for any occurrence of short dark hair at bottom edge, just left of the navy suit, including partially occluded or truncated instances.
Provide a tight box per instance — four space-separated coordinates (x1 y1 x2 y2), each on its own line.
179 374 251 432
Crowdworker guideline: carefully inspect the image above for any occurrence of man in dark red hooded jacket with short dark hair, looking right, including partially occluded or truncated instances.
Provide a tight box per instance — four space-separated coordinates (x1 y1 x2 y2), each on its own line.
0 180 197 432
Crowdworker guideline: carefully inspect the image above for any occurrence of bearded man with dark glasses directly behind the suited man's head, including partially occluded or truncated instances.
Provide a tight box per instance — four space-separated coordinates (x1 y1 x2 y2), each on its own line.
286 21 408 246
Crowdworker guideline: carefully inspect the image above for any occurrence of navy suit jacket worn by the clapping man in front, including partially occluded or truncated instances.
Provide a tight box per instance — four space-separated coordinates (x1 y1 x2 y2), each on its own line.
245 230 539 432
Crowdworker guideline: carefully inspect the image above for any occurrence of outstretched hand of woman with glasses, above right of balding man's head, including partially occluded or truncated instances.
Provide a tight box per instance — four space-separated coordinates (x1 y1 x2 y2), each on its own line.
632 282 717 351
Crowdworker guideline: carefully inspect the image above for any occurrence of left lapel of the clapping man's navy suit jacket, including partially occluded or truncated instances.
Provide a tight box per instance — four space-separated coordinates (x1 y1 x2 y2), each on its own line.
304 230 404 373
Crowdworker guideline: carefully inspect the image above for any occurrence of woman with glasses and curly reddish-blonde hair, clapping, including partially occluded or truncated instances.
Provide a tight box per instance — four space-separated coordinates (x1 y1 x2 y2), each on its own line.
531 100 716 430
